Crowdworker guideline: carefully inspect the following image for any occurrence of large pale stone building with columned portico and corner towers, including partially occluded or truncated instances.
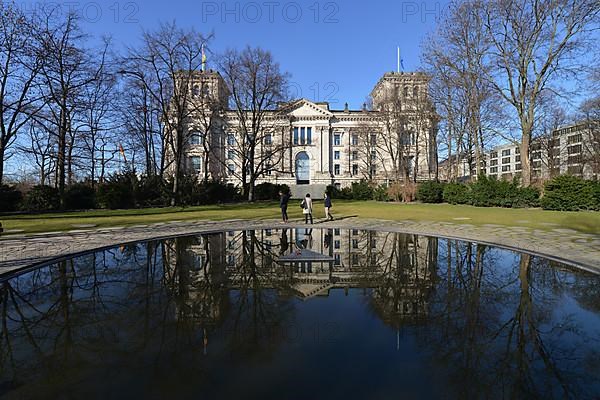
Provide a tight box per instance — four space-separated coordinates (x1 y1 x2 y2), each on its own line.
177 71 437 192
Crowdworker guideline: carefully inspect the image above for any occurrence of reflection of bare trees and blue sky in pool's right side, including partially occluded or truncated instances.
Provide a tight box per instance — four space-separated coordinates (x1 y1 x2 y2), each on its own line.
416 240 598 398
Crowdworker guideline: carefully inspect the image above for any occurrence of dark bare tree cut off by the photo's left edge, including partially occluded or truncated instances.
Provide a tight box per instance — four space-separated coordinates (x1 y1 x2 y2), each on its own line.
0 2 44 184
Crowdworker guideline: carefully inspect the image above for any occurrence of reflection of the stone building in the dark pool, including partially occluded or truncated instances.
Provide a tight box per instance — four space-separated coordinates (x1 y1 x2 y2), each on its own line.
167 228 437 320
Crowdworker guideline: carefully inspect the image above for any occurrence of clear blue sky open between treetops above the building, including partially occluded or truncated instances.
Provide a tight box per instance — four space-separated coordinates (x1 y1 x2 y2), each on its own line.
48 0 447 108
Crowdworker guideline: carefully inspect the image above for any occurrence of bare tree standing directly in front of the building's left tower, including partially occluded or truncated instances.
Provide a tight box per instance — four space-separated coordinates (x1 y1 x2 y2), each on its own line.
121 23 207 205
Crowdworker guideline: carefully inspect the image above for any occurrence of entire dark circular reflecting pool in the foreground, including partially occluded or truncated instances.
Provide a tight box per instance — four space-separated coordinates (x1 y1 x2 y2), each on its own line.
0 228 600 399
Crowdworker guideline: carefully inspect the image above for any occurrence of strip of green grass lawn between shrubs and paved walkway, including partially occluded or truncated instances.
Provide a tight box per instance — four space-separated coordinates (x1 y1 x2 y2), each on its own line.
0 200 600 234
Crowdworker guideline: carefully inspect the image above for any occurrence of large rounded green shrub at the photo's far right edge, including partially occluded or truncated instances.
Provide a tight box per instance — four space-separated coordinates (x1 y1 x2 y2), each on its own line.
540 175 600 211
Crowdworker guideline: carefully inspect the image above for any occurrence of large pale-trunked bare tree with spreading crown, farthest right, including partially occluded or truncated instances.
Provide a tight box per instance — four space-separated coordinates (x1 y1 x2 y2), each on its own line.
482 0 600 186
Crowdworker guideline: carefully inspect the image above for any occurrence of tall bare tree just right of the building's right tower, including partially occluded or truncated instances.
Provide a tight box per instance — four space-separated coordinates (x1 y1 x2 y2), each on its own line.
420 0 500 181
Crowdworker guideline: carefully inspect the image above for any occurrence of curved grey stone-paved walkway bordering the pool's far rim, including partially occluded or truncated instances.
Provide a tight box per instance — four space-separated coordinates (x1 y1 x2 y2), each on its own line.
0 218 600 276
